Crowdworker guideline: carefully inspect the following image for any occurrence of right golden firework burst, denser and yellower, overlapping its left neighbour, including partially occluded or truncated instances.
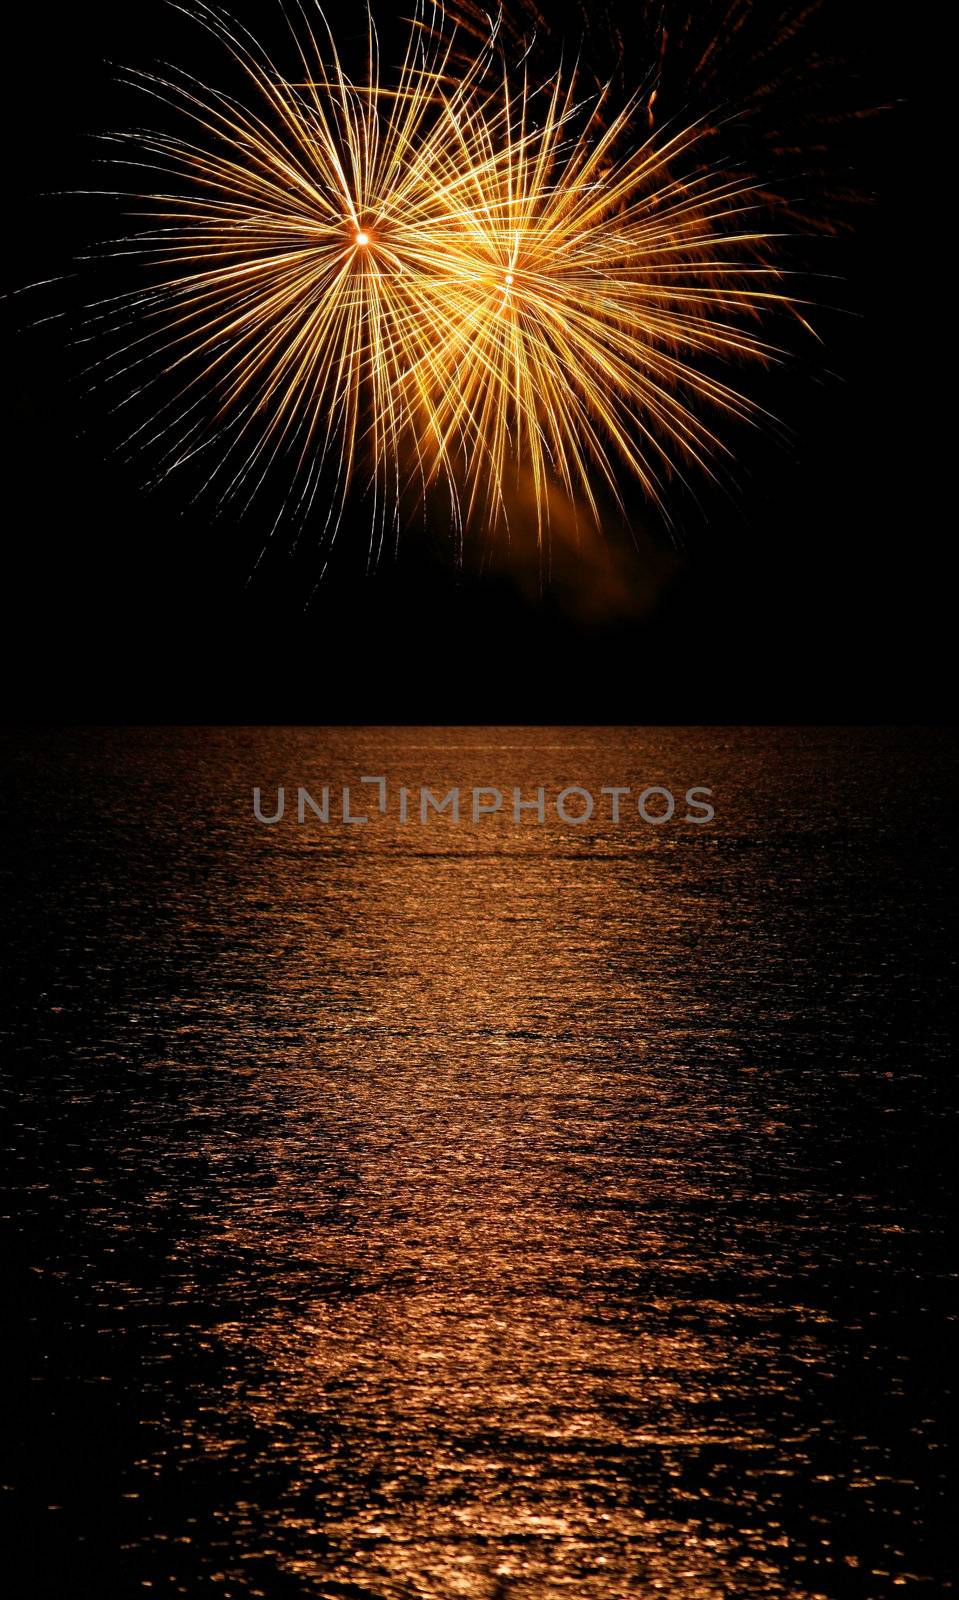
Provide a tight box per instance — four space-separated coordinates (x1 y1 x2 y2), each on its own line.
397 78 786 537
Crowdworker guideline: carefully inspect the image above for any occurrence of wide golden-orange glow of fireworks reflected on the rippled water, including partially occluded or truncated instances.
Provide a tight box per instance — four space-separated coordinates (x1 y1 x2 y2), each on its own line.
9 730 954 1600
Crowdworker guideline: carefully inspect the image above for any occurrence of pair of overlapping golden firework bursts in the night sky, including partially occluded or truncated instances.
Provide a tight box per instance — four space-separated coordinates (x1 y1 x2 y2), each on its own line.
96 0 810 554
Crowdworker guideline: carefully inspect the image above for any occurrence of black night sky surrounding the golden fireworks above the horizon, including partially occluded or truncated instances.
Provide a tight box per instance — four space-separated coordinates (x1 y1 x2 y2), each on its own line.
3 0 951 722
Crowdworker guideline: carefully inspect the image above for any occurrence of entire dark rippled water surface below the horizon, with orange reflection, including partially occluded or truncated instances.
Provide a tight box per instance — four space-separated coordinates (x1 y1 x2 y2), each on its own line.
0 728 956 1600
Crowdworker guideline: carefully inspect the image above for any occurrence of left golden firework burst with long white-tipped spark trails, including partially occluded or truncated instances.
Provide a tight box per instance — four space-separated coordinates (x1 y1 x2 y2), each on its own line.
95 6 496 563
